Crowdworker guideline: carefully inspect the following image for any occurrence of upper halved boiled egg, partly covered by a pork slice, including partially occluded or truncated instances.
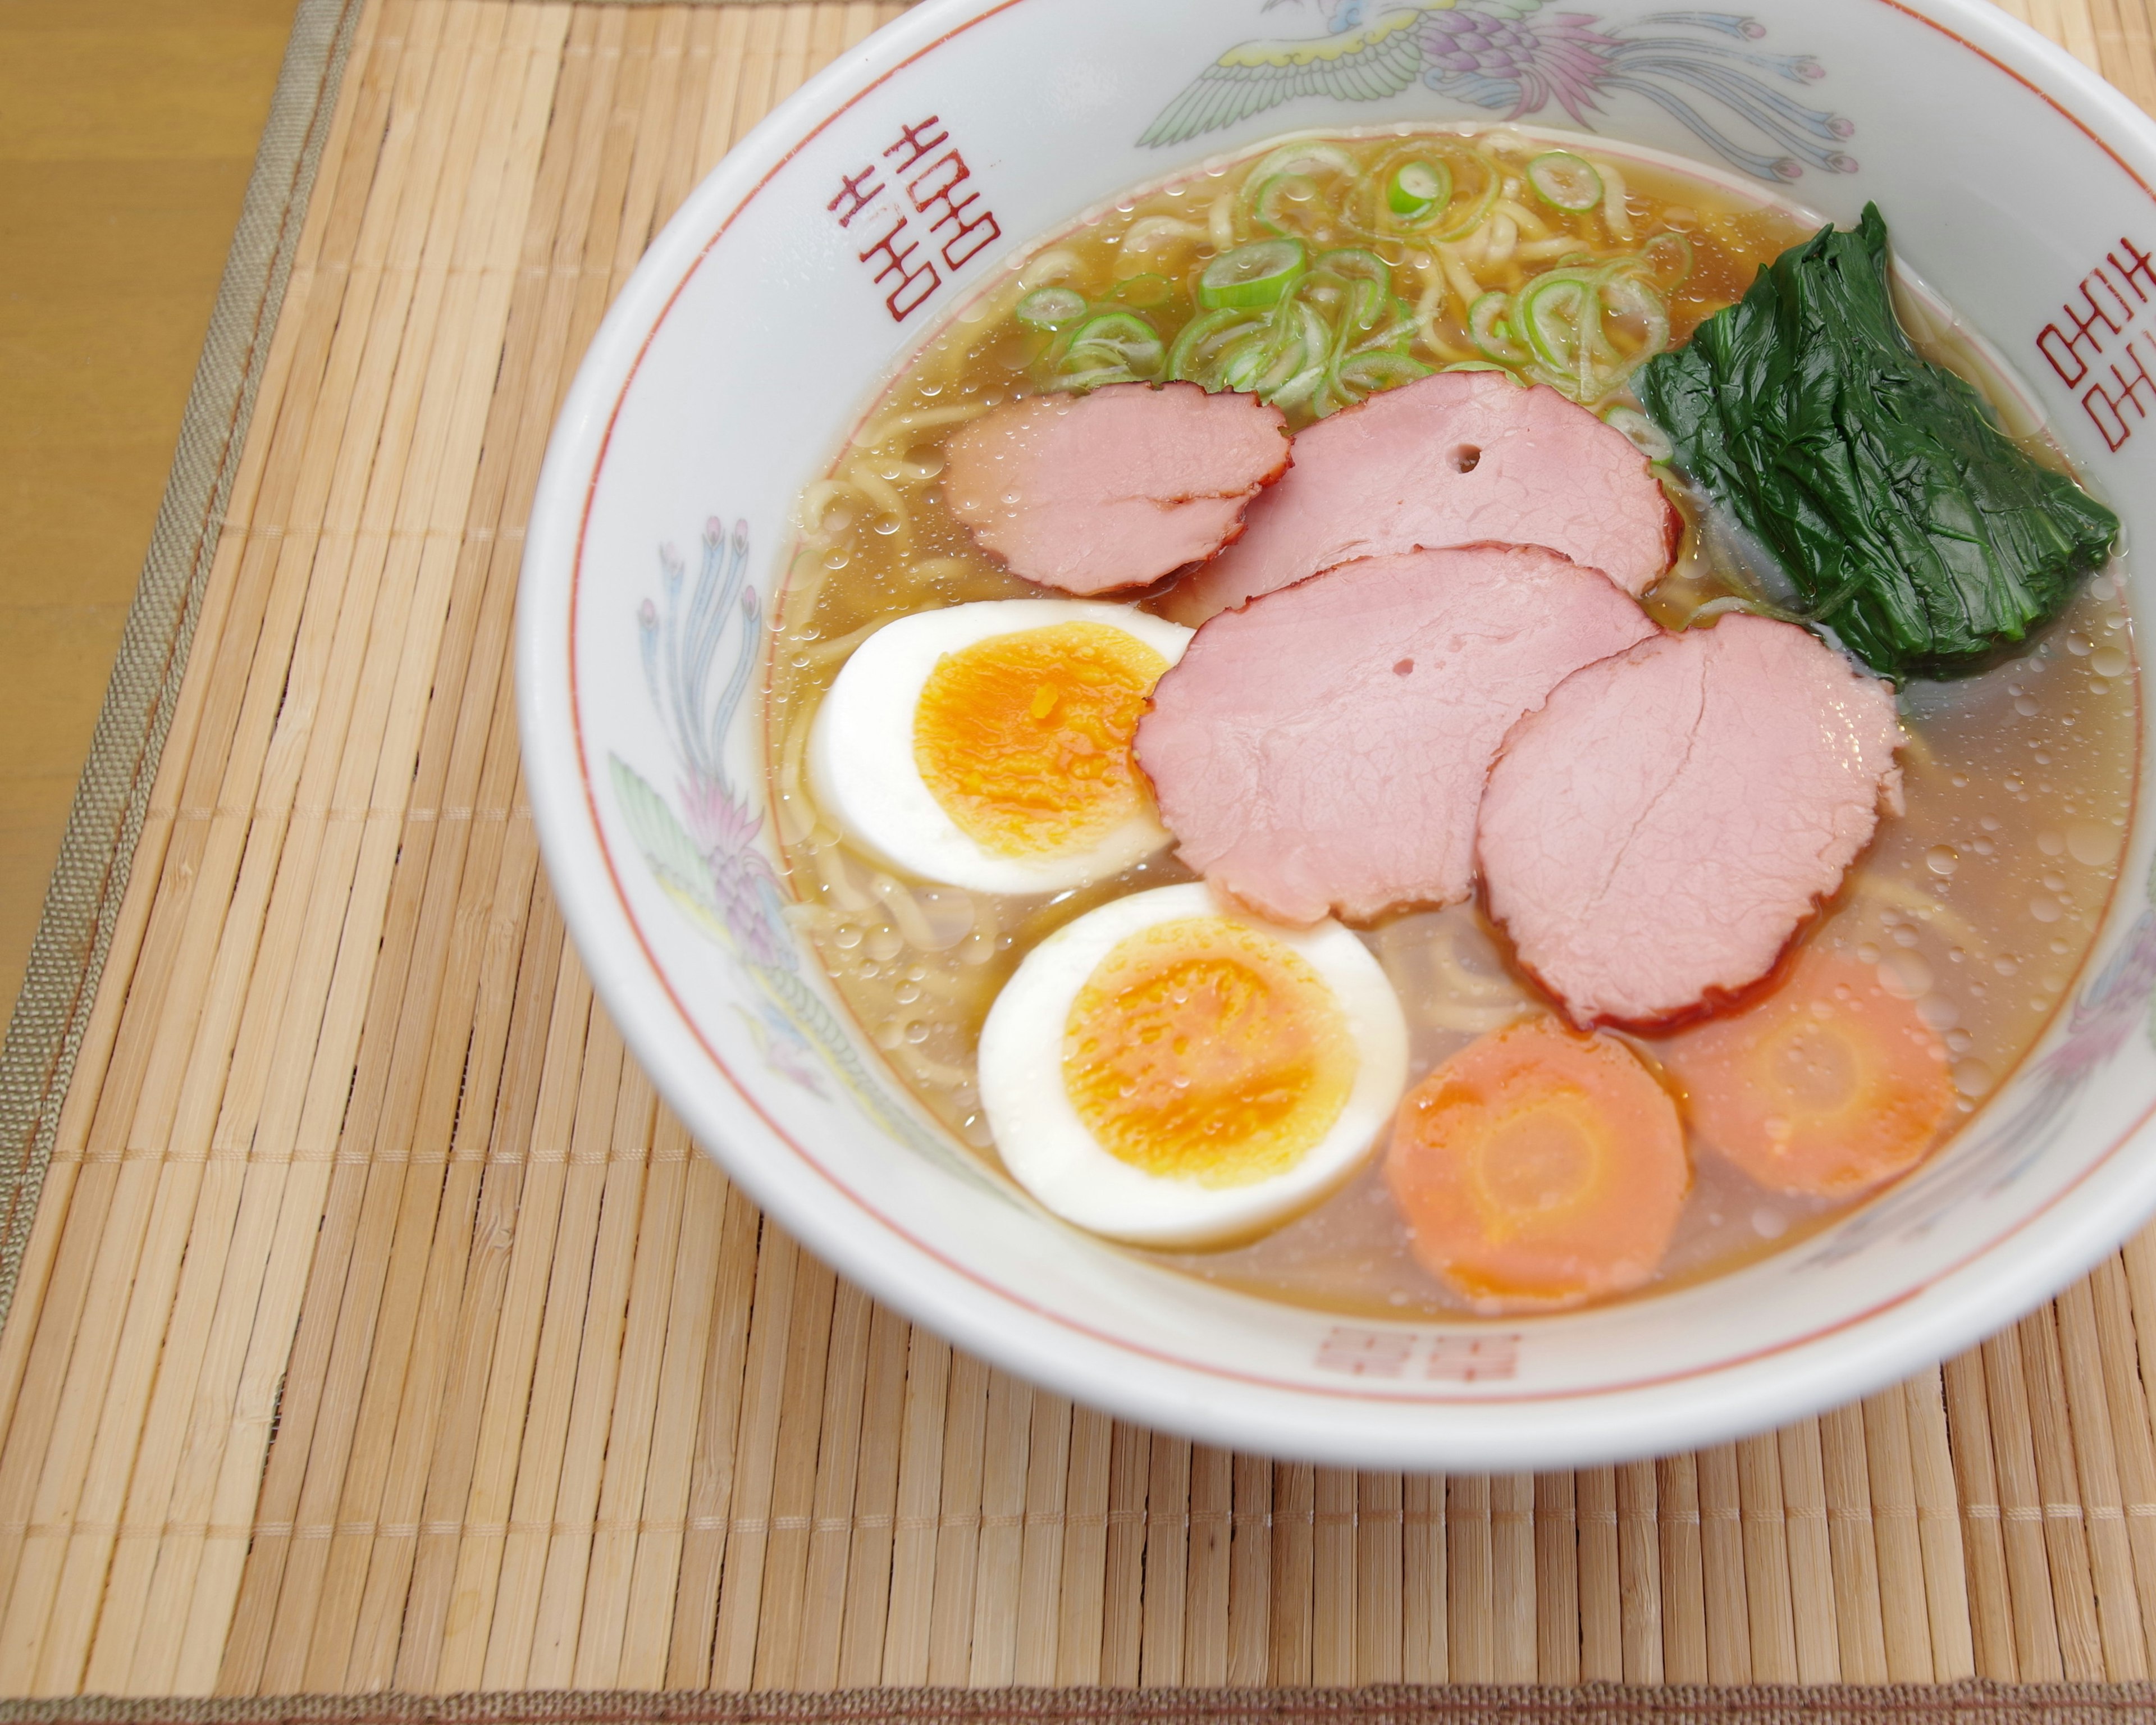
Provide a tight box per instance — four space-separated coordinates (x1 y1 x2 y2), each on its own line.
808 600 1190 893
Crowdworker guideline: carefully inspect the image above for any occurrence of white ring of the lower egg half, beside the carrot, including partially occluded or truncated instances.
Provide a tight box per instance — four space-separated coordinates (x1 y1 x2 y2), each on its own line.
981 882 1408 1247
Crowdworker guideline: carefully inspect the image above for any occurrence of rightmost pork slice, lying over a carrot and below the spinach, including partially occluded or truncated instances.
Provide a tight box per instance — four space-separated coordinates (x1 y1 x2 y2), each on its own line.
1477 617 1902 1029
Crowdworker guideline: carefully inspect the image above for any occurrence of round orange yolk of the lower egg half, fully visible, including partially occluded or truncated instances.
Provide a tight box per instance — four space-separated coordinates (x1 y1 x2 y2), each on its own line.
1063 916 1356 1186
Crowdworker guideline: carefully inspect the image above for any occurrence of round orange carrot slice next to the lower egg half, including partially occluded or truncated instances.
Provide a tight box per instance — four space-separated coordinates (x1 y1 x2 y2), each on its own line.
1384 1017 1692 1313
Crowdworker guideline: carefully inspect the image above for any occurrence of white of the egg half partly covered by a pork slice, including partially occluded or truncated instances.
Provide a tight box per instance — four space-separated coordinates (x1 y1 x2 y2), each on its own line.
808 600 1190 893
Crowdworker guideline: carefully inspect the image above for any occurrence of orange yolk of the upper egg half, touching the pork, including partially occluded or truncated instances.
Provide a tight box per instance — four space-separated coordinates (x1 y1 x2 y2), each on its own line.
914 623 1168 856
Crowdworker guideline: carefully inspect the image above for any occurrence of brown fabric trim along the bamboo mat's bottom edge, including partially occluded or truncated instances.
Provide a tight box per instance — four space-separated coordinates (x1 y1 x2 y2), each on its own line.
0 1680 2156 1725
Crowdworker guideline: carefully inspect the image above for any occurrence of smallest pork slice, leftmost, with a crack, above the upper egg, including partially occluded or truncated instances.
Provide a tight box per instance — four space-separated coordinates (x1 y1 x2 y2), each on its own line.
942 384 1287 593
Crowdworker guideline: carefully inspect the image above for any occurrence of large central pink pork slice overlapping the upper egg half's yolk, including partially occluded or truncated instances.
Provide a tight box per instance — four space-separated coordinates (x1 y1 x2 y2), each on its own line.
1136 546 1656 923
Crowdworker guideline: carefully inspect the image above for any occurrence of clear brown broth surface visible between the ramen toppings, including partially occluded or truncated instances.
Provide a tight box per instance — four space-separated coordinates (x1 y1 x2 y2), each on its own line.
768 131 2139 1320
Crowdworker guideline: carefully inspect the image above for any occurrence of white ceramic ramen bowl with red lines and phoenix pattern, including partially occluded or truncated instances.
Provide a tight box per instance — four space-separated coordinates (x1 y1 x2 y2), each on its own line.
518 0 2156 1471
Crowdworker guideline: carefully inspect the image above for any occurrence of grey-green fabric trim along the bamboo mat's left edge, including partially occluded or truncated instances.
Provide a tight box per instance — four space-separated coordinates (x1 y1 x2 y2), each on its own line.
0 0 364 1324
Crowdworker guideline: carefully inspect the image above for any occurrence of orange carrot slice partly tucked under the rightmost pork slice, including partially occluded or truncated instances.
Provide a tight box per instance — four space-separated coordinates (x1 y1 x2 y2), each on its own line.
1660 947 1953 1199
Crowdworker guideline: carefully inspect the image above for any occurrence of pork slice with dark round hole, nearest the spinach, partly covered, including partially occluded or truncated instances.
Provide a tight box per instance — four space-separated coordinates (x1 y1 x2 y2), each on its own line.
1164 371 1682 626
